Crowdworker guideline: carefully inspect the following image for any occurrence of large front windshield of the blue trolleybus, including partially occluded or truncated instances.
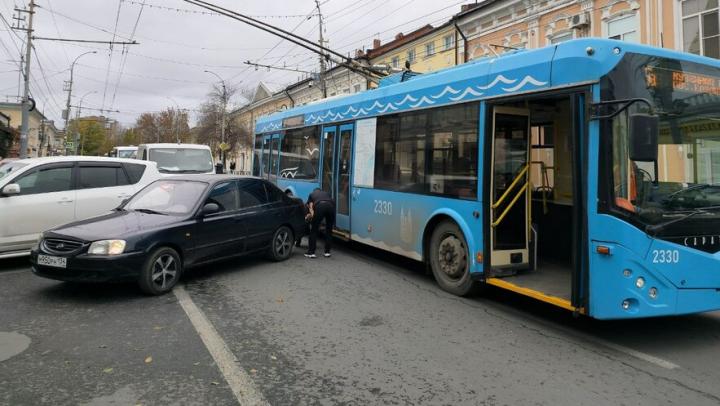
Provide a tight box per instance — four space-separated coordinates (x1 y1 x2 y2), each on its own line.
604 55 720 224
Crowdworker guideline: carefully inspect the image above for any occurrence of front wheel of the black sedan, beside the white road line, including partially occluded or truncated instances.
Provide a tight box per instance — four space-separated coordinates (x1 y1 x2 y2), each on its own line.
139 247 182 295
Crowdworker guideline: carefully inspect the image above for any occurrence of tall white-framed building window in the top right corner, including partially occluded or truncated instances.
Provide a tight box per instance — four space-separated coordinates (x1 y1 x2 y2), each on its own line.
682 0 720 58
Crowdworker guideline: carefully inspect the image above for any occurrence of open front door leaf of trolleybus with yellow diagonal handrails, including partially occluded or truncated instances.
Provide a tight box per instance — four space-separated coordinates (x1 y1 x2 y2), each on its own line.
488 107 531 275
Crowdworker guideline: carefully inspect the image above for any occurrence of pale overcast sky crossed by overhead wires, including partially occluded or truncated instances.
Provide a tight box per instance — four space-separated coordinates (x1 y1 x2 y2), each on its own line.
0 0 473 128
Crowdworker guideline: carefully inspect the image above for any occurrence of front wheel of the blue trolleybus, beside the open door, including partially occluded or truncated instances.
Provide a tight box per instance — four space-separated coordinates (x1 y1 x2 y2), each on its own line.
429 221 477 296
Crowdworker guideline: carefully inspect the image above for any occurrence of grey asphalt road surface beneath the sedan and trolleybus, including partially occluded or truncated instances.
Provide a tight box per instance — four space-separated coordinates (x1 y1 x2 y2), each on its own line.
0 246 720 405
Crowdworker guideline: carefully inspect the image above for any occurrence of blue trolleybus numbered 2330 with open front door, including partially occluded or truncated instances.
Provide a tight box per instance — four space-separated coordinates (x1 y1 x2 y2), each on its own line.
253 39 720 319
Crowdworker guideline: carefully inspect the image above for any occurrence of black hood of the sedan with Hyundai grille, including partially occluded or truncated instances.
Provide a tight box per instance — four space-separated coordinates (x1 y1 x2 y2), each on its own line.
46 211 181 241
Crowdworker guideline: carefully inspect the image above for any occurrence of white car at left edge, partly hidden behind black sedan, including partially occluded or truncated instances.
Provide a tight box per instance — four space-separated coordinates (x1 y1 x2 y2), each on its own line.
0 156 161 258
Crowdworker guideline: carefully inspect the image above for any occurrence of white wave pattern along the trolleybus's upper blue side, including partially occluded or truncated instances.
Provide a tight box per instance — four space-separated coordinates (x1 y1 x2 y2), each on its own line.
260 75 548 132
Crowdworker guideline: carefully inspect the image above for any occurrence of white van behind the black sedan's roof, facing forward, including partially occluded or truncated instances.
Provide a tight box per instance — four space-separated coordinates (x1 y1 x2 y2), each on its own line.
137 143 215 175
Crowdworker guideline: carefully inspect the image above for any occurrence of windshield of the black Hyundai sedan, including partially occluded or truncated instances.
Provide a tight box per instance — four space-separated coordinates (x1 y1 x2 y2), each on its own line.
123 180 208 215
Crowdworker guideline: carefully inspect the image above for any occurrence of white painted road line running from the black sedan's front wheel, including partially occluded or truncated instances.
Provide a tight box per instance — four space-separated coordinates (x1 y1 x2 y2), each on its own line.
173 286 269 406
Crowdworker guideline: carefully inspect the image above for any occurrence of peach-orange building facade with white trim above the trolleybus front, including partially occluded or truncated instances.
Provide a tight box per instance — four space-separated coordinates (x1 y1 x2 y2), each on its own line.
455 0 704 63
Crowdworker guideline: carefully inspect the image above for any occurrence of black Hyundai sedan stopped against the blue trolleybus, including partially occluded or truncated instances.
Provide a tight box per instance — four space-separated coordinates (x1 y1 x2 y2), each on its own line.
30 175 305 295
